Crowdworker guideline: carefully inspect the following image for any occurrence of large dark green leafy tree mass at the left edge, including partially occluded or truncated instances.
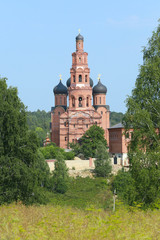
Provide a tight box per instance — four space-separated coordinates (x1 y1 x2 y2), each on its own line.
0 78 50 204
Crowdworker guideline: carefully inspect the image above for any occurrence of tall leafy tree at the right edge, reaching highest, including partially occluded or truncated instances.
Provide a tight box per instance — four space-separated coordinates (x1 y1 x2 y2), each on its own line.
123 22 160 205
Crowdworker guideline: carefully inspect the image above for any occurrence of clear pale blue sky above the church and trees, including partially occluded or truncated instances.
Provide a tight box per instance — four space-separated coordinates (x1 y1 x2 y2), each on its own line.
0 0 160 113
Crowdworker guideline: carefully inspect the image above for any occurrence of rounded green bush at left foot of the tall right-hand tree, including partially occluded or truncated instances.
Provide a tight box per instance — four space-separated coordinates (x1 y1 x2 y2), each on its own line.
112 169 137 205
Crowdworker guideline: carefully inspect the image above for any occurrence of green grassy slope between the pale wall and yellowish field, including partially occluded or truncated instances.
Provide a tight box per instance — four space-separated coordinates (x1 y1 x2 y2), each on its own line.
49 177 112 209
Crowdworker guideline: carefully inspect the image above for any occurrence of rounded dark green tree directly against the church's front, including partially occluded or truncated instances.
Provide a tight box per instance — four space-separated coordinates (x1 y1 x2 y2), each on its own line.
80 125 107 158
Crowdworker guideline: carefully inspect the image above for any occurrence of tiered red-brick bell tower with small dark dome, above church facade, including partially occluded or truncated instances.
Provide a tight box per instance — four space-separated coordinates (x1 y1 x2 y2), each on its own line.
68 32 92 110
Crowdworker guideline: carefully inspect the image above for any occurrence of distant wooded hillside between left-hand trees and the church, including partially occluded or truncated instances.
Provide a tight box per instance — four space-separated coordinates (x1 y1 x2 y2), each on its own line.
27 109 51 146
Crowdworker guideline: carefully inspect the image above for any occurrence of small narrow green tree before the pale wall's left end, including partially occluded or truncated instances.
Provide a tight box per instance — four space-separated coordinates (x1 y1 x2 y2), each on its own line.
53 152 69 193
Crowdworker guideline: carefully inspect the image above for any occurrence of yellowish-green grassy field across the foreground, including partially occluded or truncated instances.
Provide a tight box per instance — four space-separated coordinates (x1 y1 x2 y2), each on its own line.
0 204 160 240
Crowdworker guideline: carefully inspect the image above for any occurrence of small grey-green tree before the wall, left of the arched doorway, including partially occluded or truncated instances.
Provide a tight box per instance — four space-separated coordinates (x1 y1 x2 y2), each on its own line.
94 143 112 177
